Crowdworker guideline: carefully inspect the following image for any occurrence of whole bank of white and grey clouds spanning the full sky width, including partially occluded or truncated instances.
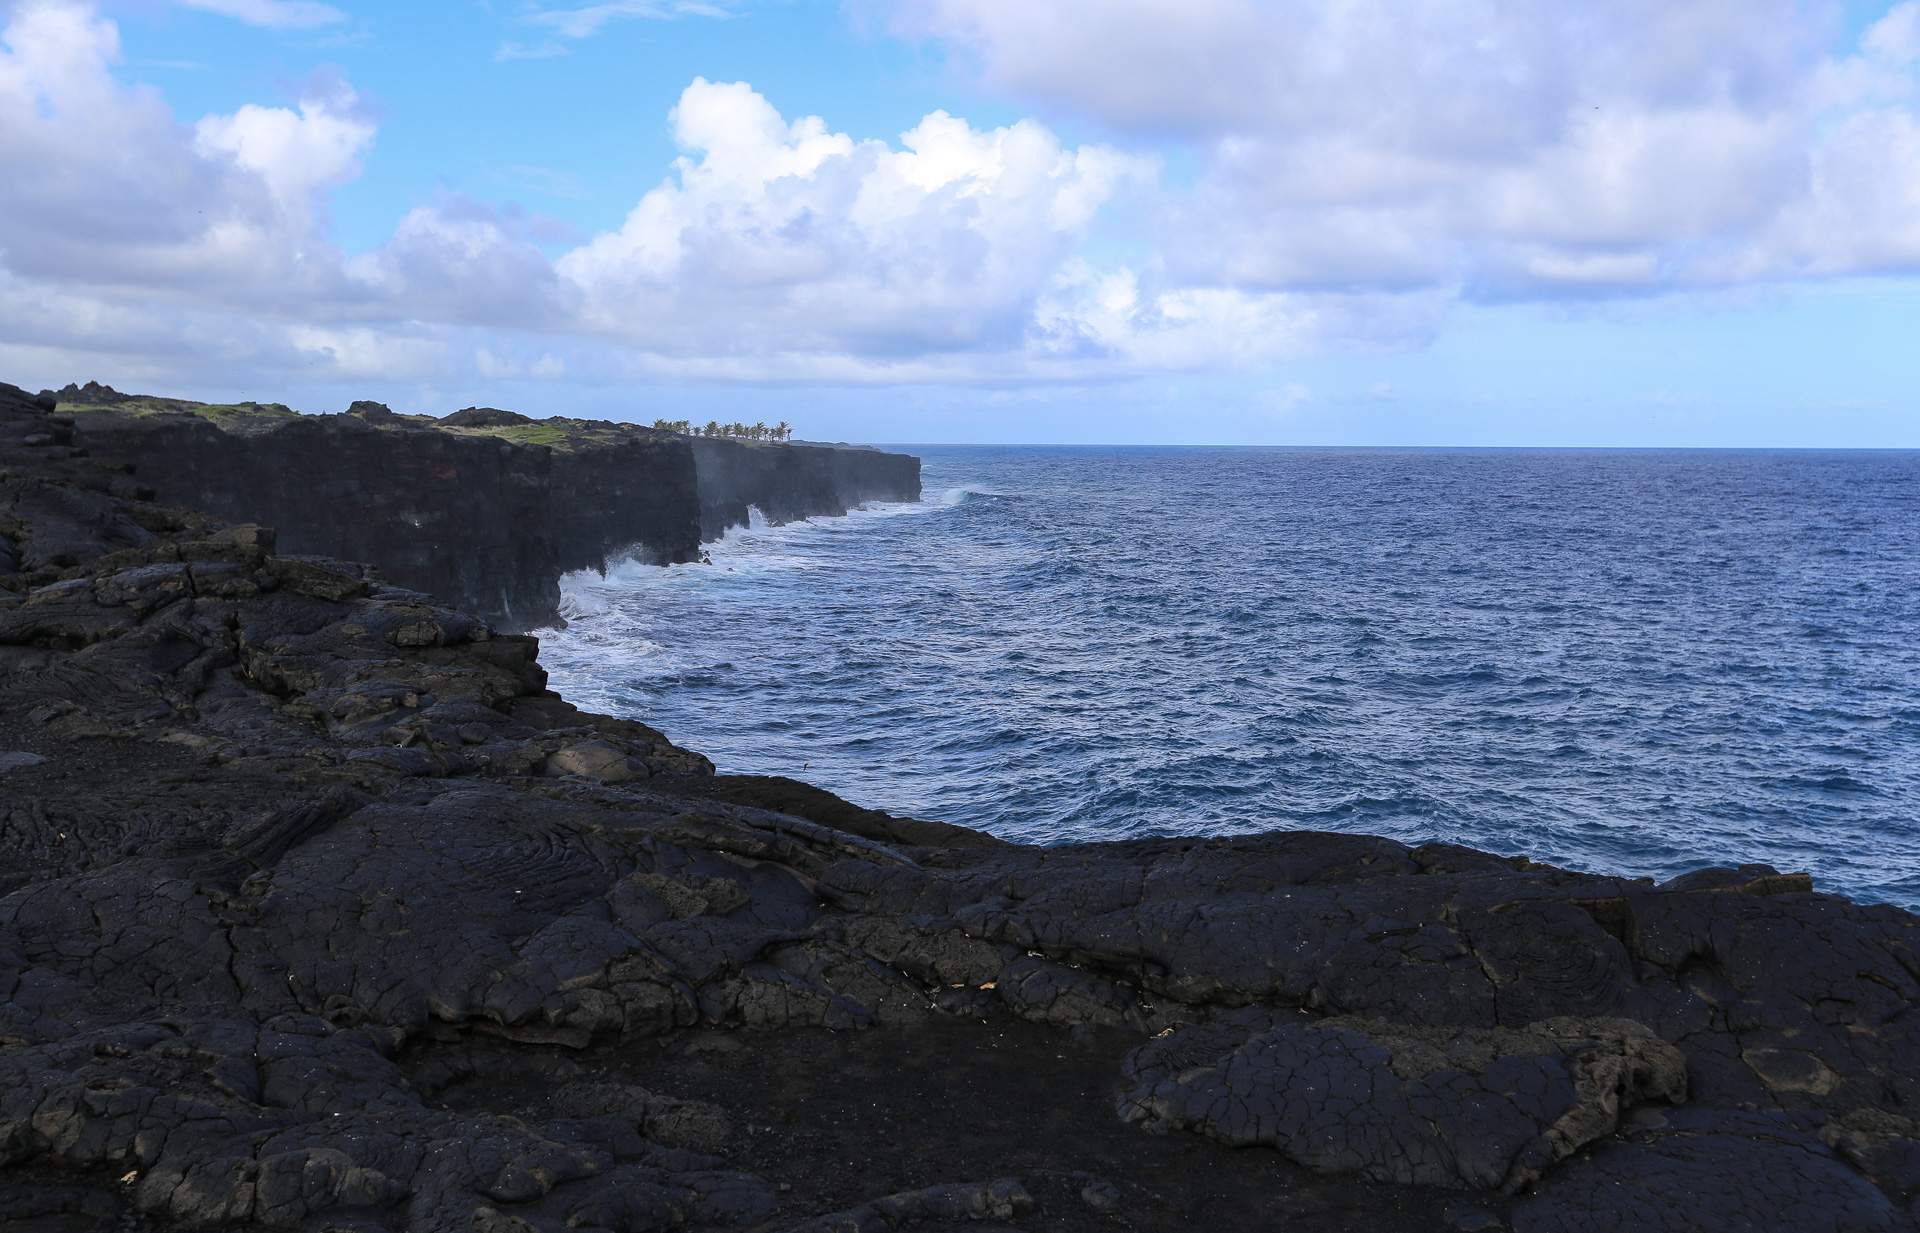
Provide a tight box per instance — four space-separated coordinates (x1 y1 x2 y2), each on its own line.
0 0 1920 391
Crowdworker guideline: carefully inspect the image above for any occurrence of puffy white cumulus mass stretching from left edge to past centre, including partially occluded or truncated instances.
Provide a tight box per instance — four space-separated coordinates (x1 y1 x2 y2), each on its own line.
0 0 1221 380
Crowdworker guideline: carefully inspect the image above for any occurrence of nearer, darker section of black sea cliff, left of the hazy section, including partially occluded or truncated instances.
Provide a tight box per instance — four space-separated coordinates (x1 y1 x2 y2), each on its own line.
75 411 699 628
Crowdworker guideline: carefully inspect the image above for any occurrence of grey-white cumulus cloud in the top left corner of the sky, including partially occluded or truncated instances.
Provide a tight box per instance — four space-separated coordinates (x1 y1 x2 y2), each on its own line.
0 0 374 297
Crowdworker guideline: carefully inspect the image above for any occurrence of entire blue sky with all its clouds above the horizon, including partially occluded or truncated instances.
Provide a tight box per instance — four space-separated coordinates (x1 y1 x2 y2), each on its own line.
0 0 1920 447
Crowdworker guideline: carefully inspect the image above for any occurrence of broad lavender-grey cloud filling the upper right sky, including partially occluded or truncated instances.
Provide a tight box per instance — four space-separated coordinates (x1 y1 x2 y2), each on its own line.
893 0 1920 298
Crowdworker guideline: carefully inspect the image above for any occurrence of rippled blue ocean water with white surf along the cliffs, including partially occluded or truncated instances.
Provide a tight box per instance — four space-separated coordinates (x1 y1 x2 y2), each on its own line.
543 446 1920 907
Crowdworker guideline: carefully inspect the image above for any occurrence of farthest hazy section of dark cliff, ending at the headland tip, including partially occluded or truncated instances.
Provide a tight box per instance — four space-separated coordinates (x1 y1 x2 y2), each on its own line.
693 438 920 540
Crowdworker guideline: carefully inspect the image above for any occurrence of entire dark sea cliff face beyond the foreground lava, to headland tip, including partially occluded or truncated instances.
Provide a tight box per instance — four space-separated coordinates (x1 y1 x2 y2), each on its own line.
73 403 920 630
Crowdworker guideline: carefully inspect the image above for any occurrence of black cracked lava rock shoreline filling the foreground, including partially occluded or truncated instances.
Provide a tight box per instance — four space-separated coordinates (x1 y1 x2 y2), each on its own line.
0 376 1920 1233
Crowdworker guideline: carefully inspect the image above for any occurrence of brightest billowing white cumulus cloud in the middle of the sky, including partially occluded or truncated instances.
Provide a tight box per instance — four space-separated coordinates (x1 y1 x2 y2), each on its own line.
557 81 1150 371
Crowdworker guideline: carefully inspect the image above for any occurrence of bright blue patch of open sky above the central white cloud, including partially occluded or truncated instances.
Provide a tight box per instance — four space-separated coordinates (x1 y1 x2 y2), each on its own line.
114 0 1023 252
